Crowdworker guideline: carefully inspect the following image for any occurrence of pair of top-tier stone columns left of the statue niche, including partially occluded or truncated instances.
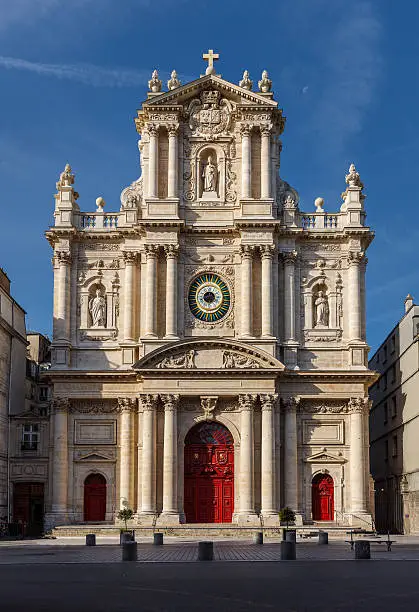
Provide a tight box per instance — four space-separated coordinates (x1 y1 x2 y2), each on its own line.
147 124 179 198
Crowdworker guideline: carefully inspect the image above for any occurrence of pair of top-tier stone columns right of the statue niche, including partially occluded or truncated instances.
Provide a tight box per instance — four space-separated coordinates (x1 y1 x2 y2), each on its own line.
241 123 271 200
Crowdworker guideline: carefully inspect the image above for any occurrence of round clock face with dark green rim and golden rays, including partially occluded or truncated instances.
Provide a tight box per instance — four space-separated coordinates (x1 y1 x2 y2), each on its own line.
188 273 231 323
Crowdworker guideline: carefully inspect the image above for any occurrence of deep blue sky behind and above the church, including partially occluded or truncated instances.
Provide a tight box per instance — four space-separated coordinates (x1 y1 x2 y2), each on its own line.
0 0 419 348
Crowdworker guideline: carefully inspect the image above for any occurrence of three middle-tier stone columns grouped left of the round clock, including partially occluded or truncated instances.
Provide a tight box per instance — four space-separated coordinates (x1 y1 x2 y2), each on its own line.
124 245 179 341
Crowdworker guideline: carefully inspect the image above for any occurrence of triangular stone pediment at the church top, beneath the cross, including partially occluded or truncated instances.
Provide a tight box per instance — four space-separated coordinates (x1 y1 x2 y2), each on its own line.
143 74 278 109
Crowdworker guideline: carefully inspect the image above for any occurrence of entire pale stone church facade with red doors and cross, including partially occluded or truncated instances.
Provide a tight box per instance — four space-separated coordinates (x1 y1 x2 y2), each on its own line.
46 51 373 526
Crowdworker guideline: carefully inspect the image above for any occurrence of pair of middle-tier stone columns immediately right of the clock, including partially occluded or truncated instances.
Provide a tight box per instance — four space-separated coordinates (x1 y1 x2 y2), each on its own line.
241 244 275 338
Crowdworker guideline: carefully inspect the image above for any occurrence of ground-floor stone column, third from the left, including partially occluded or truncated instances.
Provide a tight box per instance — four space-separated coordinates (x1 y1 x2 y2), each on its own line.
139 395 158 516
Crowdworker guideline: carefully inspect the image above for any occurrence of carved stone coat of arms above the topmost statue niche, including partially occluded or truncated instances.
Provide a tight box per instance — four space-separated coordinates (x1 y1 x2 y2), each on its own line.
188 90 232 139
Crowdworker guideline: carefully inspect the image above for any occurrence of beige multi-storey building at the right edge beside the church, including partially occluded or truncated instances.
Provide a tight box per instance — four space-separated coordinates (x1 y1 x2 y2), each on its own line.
369 295 419 534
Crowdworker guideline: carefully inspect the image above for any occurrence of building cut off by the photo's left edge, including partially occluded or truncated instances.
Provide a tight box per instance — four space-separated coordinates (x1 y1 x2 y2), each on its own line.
0 268 27 521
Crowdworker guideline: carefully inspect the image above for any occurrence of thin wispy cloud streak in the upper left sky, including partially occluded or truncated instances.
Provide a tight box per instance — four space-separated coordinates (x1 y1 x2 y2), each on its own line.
0 56 152 87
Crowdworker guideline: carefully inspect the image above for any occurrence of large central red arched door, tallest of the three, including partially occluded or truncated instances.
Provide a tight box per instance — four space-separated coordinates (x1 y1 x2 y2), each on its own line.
184 422 234 523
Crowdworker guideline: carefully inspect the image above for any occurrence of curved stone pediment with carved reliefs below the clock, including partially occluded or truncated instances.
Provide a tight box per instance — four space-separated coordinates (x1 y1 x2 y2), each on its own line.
132 339 285 373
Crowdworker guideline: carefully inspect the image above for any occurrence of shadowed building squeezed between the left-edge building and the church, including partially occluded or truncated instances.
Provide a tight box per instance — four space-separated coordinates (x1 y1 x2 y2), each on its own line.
9 332 53 534
